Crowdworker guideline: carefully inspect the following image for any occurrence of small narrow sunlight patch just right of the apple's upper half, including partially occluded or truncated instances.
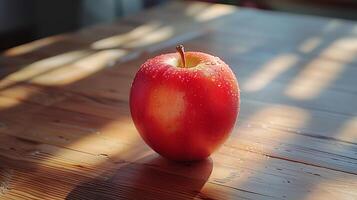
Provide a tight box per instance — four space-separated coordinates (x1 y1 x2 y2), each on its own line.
243 54 298 92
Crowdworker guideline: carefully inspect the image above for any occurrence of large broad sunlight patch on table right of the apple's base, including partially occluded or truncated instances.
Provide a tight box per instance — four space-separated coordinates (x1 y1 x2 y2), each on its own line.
201 104 311 196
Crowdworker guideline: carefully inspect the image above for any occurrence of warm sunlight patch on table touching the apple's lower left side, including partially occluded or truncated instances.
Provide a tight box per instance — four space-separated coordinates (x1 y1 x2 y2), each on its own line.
42 117 146 167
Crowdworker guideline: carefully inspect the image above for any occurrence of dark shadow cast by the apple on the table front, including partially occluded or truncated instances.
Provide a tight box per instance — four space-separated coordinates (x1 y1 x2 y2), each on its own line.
66 156 213 200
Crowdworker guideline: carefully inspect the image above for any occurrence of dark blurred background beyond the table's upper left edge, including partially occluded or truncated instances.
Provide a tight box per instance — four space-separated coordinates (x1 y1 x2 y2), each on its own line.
0 0 163 50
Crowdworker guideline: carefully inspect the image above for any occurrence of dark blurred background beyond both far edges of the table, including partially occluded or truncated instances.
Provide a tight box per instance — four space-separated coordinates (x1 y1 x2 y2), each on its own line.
0 0 357 51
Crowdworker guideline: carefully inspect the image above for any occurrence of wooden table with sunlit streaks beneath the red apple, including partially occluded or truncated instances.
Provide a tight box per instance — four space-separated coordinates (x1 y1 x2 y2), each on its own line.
0 2 357 200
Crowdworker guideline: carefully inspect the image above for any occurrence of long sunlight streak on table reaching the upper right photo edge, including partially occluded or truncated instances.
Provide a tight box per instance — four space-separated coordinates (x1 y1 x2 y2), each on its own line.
285 37 357 100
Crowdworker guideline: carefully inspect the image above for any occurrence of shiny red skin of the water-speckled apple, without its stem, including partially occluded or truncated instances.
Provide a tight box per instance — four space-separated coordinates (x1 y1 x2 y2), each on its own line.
130 52 240 161
